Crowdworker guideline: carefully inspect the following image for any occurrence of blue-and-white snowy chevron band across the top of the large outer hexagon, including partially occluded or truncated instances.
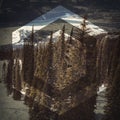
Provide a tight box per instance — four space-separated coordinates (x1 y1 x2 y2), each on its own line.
12 6 106 44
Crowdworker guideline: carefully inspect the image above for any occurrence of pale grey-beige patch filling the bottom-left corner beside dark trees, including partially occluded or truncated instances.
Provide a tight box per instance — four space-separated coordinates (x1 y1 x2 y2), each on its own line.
0 61 29 120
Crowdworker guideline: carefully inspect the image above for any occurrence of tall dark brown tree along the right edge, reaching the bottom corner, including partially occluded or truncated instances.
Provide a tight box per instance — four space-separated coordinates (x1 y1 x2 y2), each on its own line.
103 39 120 120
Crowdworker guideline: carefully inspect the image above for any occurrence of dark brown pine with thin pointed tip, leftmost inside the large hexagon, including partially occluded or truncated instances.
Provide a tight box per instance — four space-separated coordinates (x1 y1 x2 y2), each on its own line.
23 26 34 85
